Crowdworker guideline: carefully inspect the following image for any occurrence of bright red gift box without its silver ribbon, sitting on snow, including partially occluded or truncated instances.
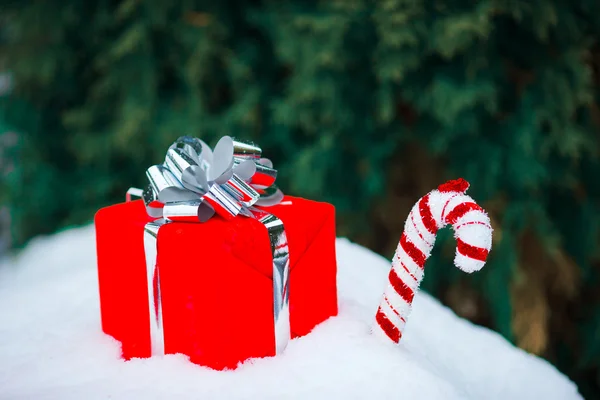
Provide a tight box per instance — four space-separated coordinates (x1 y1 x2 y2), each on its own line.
95 196 337 369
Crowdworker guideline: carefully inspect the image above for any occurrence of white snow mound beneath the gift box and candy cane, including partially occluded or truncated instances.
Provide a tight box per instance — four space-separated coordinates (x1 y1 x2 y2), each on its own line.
0 226 581 400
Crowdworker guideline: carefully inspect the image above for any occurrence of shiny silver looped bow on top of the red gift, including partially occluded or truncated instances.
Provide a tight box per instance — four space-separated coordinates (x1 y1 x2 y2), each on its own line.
143 136 283 222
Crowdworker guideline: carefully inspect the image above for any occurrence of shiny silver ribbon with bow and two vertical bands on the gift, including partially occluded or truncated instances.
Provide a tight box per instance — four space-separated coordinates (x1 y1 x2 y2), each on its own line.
127 136 290 354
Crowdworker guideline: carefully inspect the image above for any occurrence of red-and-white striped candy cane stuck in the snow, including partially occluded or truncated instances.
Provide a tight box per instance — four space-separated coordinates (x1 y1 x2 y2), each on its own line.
374 178 492 343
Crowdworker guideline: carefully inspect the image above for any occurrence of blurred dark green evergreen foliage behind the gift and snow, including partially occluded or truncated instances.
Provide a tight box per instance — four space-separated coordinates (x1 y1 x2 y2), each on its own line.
0 0 600 398
